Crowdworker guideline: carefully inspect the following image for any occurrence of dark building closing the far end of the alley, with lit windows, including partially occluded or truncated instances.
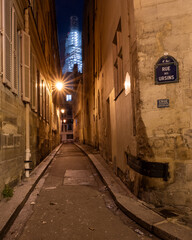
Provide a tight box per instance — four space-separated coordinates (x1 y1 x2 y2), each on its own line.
60 64 82 143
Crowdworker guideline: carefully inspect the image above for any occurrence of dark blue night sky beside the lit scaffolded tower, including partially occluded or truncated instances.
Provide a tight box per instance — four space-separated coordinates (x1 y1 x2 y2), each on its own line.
55 0 83 62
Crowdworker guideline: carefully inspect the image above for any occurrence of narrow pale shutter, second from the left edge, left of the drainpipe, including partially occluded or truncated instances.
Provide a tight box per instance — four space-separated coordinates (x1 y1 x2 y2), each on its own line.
12 8 18 94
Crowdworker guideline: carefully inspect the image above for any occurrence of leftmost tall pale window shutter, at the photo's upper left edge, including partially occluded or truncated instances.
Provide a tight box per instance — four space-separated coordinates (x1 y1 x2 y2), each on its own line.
2 0 12 87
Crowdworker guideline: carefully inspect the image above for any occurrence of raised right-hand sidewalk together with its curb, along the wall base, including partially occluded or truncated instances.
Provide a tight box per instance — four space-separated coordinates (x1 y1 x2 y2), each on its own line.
76 144 192 240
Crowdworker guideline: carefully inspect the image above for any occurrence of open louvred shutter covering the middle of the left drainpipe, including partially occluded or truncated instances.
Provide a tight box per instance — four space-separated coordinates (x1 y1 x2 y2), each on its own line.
22 31 30 102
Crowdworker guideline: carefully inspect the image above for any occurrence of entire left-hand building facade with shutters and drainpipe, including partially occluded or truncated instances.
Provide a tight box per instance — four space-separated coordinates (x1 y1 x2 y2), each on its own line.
0 0 60 198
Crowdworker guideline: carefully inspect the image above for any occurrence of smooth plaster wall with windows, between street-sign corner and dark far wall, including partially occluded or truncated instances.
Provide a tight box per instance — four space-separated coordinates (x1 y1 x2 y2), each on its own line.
92 0 137 184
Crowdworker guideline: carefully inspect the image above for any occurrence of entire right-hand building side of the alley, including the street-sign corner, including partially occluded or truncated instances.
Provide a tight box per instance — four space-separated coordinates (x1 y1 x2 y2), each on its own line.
81 0 192 207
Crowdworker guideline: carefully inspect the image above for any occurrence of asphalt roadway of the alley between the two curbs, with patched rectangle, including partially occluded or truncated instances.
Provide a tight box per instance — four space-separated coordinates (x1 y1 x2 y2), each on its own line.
4 144 158 240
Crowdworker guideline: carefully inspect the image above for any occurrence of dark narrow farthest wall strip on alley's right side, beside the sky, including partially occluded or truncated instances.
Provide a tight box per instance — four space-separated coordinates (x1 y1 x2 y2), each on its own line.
82 0 95 146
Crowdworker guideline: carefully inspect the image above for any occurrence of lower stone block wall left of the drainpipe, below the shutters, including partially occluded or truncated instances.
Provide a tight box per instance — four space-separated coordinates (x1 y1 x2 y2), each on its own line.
0 82 25 192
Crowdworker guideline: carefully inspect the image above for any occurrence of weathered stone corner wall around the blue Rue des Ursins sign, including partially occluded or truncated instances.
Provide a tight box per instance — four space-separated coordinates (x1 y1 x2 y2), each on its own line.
135 0 192 206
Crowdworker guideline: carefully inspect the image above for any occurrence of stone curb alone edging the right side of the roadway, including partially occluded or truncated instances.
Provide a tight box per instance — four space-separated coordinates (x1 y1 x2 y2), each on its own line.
75 143 192 240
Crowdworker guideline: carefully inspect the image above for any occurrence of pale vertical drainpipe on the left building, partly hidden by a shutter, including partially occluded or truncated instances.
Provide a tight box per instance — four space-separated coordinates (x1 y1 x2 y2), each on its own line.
25 8 31 178
